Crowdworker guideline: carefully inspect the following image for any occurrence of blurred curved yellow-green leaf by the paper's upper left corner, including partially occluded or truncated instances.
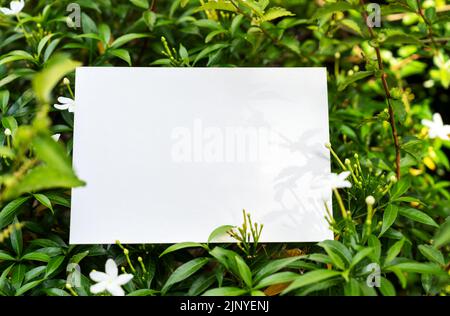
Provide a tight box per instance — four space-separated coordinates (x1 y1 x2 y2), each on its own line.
33 54 81 104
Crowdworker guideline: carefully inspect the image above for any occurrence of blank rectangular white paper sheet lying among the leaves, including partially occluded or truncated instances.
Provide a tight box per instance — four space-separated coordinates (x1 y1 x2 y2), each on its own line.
70 67 333 244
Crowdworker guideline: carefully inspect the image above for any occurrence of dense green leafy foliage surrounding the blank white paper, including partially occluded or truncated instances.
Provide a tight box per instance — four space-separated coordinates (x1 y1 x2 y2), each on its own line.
0 0 450 296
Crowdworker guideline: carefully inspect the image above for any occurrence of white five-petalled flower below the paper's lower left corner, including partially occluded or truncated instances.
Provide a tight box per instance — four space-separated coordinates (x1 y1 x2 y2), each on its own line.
89 259 133 296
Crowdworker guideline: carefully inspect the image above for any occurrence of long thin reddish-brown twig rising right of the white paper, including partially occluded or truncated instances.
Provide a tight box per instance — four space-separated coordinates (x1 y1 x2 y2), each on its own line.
360 0 401 179
